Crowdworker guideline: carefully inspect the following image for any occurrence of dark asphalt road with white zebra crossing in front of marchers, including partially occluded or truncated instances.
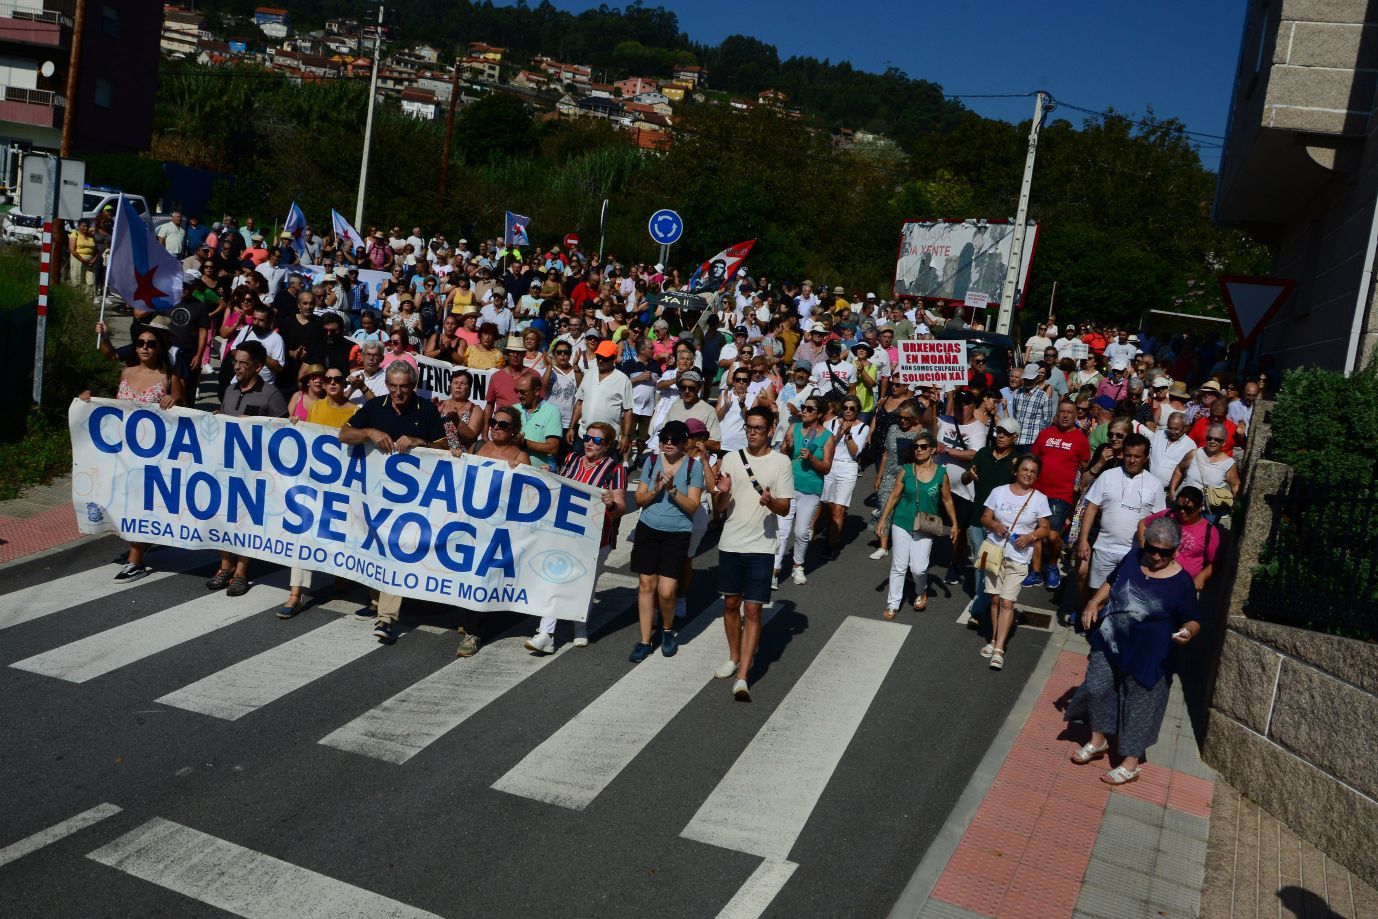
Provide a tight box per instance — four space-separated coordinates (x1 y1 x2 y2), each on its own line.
0 484 1051 918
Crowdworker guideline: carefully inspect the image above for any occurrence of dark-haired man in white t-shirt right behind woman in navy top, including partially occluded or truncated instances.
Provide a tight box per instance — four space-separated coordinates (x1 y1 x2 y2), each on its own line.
1076 434 1167 597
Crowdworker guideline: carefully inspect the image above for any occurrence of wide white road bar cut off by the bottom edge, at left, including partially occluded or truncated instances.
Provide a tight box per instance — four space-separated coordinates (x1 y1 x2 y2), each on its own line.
87 817 434 919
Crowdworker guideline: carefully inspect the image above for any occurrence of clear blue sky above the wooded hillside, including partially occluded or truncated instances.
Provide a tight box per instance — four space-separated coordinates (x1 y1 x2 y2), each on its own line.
531 0 1246 169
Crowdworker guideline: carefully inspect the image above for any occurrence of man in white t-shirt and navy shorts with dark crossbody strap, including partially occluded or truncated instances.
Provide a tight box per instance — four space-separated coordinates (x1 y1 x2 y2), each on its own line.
712 405 794 701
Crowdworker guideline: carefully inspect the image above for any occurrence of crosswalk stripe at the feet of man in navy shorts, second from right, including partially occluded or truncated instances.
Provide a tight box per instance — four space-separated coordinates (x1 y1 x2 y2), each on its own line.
493 601 770 810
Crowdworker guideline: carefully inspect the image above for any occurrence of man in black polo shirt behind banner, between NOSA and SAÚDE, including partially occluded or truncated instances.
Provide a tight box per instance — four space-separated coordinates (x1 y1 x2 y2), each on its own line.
340 361 445 645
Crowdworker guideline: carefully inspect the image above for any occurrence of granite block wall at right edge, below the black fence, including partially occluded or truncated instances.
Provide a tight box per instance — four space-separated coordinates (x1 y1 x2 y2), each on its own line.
1203 402 1378 886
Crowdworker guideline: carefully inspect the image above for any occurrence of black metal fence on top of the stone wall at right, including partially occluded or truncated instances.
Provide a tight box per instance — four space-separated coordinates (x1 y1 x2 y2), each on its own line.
1244 478 1378 641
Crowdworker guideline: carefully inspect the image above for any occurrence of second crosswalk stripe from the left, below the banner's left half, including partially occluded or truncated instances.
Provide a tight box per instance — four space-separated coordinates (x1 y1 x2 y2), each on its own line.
10 570 287 683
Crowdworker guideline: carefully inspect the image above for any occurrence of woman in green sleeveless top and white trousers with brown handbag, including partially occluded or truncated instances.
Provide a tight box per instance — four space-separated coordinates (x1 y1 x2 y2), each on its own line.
876 431 959 619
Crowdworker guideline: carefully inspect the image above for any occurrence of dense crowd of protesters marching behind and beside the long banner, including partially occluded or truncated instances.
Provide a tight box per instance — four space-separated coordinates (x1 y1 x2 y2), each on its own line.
80 215 1256 727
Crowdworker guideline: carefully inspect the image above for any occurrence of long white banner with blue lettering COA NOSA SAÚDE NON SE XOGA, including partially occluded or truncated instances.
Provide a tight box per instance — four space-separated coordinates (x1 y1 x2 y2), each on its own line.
68 400 604 619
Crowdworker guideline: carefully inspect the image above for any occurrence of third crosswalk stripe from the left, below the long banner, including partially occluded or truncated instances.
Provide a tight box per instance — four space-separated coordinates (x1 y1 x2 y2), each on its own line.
157 619 382 721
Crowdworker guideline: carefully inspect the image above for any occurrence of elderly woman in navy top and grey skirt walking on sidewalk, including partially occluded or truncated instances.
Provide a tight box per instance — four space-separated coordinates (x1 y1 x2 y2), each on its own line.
1065 517 1200 785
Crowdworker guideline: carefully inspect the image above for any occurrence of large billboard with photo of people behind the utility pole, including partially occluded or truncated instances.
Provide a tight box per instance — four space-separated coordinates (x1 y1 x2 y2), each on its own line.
894 220 1038 306
